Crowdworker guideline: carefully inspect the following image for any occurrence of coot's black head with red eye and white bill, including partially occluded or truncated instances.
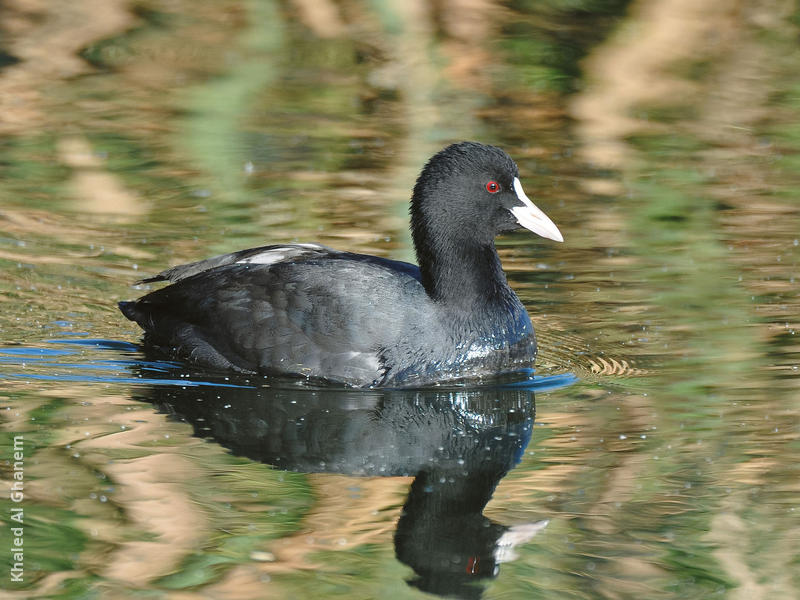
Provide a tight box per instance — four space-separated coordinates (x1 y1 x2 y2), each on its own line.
411 142 563 263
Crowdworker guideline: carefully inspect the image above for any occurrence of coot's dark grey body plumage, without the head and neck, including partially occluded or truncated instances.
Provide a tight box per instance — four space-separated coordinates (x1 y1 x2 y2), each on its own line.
120 244 536 387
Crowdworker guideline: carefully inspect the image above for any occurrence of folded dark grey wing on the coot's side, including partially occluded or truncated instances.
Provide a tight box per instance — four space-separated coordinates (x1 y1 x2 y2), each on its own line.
121 246 431 385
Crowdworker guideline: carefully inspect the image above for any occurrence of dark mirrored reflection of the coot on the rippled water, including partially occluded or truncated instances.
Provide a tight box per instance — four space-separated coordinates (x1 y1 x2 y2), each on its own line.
131 377 547 598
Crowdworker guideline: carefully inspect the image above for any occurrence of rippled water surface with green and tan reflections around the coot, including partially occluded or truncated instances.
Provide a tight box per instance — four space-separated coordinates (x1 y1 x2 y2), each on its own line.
0 0 800 600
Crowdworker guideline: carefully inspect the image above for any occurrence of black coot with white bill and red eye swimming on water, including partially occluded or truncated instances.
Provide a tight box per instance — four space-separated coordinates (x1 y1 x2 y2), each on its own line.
119 142 563 387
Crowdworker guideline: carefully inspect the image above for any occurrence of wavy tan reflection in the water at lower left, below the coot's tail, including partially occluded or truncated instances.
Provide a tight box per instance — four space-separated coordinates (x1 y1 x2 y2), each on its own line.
56 397 209 585
